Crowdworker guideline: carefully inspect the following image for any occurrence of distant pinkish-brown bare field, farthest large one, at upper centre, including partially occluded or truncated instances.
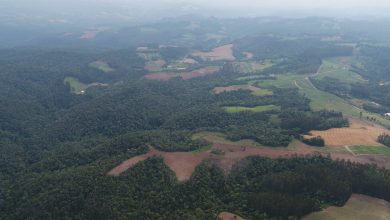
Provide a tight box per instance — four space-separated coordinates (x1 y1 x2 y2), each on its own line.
192 44 236 61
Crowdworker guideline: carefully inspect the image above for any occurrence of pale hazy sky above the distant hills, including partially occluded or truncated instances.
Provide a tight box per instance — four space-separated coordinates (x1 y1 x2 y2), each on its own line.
0 0 390 26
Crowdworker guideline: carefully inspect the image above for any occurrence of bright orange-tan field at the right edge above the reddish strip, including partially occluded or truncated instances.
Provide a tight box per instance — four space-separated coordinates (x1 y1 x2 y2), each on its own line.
307 118 390 146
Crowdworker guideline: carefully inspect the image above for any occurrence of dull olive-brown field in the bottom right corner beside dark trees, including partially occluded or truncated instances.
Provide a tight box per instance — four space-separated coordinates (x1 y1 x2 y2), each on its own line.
304 194 390 220
